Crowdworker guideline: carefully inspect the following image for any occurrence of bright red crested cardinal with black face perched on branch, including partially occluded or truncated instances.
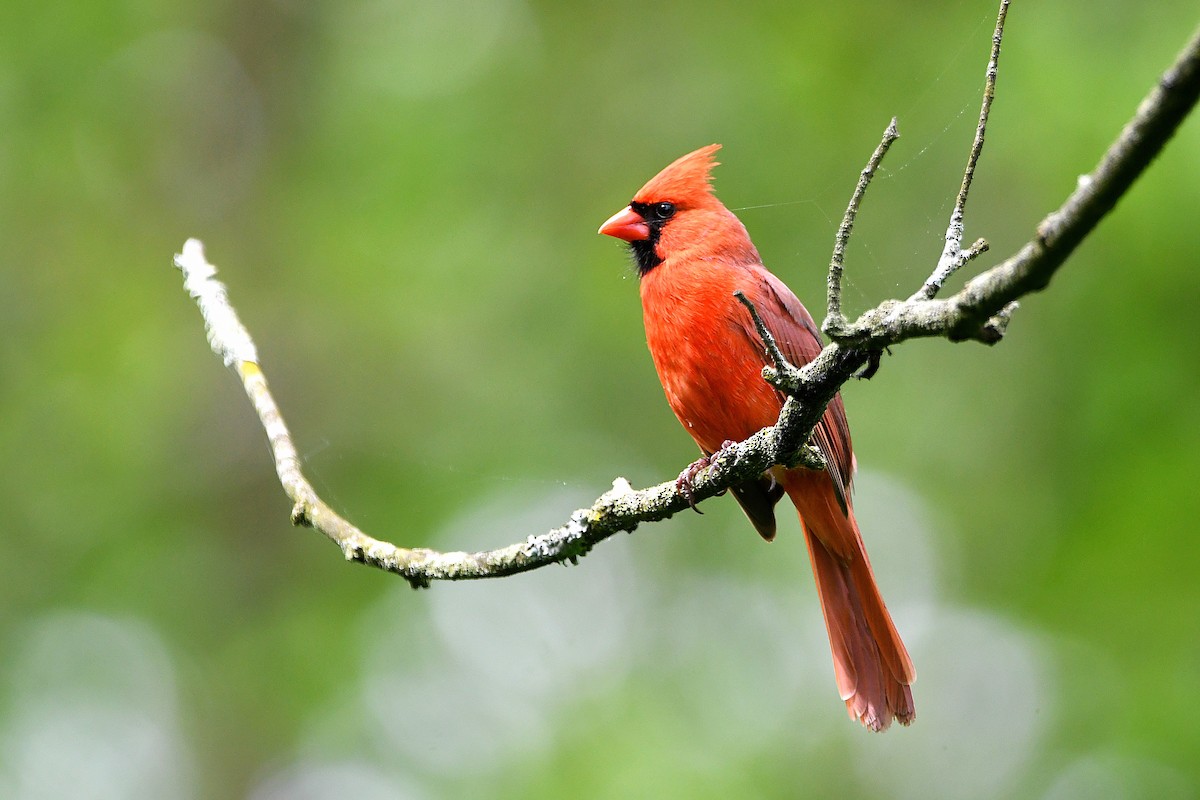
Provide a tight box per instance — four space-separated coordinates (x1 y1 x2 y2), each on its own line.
600 144 916 730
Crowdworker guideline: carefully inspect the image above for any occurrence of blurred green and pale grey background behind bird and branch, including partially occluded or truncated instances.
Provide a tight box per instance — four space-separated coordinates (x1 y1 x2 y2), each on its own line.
0 0 1200 800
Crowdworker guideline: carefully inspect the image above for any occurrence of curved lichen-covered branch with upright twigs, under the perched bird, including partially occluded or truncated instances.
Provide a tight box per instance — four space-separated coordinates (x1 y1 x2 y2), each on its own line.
175 9 1200 587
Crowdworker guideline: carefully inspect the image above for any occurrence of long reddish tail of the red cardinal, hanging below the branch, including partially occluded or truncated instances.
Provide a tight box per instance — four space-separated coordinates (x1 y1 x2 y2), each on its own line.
784 470 917 730
